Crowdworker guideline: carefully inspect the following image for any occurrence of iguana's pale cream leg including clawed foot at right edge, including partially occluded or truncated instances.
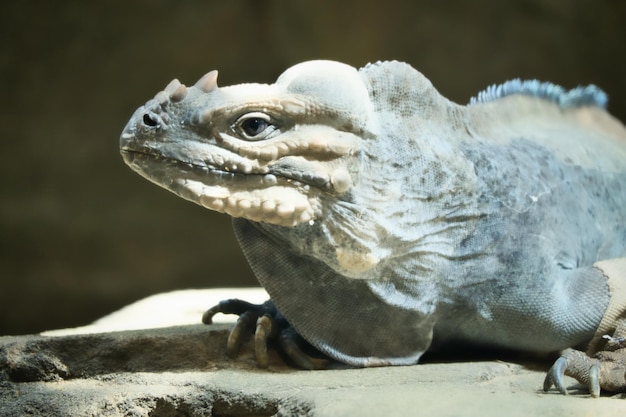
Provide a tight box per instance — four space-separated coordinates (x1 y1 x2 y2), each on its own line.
543 258 626 397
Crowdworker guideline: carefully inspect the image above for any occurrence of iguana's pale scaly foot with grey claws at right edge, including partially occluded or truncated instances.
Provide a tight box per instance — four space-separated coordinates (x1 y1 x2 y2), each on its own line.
543 329 626 397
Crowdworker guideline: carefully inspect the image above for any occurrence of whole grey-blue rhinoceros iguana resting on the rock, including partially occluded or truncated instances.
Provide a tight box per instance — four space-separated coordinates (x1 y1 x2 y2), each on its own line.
120 61 626 395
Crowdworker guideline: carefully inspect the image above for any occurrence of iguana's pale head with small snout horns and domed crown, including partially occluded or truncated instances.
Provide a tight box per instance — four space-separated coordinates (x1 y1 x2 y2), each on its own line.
120 61 372 226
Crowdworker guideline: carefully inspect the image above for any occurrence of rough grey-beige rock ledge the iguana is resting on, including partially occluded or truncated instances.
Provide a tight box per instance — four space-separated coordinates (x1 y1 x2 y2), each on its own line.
0 291 626 417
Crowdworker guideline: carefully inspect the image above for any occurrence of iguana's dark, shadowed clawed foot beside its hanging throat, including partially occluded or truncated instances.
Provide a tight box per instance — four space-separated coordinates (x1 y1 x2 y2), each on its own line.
202 299 328 369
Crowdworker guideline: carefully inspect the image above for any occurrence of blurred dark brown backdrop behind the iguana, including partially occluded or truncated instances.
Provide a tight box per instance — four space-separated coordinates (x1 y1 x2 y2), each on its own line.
0 0 626 334
